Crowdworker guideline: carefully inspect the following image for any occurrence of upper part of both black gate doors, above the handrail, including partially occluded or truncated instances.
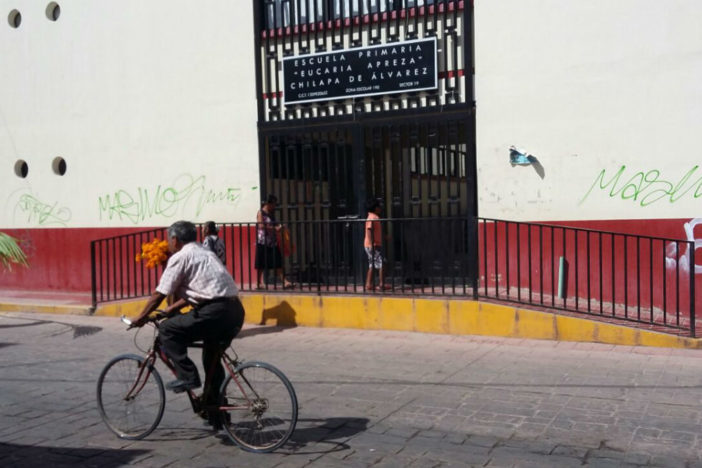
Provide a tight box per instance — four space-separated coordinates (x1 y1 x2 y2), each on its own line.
261 118 475 221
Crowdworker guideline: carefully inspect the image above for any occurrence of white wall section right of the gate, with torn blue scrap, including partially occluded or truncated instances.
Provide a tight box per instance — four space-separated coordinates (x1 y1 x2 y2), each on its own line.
475 0 702 220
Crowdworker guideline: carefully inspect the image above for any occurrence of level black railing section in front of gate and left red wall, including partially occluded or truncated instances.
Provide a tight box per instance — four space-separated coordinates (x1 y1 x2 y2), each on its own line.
91 218 475 304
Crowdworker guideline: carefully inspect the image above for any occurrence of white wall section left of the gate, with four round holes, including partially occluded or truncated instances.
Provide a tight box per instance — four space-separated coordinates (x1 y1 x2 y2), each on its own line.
0 0 260 228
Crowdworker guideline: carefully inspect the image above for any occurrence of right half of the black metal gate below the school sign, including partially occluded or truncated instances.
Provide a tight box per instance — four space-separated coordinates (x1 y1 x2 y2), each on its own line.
362 116 477 284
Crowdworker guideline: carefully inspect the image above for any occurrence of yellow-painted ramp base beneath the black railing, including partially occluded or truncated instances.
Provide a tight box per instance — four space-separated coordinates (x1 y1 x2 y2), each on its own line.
95 293 702 348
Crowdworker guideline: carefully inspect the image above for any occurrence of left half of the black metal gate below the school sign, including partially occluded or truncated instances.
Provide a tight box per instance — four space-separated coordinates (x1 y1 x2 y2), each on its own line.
261 127 360 283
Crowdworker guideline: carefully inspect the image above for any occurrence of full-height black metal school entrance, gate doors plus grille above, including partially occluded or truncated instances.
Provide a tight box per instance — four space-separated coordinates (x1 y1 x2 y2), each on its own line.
253 0 478 286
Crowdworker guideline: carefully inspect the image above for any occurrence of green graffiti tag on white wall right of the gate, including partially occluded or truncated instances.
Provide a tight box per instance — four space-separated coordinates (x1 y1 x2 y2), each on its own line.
578 165 702 207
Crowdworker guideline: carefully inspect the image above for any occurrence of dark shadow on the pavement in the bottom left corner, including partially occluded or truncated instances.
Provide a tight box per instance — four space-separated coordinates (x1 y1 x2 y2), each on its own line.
0 442 149 468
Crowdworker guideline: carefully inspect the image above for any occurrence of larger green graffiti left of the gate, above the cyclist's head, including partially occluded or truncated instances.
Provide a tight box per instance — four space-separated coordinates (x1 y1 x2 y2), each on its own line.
98 174 241 224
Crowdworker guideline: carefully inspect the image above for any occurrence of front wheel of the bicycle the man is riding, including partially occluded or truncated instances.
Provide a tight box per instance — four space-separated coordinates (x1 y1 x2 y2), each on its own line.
97 354 166 440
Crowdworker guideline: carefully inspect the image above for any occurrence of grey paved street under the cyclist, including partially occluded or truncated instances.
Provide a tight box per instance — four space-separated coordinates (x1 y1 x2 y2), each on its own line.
0 313 702 468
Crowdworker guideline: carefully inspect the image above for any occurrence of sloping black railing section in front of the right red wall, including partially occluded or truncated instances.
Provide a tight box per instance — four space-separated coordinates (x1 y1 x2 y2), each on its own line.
478 218 696 336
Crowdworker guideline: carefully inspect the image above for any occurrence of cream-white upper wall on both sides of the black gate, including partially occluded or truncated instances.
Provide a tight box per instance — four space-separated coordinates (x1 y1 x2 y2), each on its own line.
5 0 702 228
